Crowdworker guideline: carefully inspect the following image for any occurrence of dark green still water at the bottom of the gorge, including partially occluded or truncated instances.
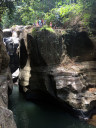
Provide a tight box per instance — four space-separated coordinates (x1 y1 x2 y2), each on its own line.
9 85 95 128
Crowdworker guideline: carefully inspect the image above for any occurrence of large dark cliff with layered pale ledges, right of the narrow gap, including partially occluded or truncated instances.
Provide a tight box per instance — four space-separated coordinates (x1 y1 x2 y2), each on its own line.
19 28 96 117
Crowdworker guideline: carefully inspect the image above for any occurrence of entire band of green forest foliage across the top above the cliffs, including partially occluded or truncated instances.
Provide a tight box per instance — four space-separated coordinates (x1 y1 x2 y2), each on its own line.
0 0 96 28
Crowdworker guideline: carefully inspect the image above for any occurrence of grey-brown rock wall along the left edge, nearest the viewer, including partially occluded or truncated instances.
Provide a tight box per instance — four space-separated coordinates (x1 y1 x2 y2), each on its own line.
0 30 16 128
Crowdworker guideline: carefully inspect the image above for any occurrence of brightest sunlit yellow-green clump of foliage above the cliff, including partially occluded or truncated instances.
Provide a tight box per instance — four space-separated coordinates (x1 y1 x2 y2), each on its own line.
45 4 82 26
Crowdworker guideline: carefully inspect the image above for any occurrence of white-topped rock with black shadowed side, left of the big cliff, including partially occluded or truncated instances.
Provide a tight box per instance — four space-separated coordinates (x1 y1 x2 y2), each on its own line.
3 29 19 73
